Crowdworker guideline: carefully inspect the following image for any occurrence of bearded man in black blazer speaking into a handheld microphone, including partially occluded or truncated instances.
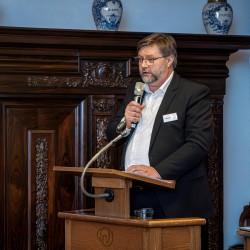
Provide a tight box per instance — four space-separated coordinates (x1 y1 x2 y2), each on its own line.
107 34 213 218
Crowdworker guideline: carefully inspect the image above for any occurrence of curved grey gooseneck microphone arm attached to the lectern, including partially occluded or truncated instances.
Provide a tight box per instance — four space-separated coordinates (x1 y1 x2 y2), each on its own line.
80 129 128 201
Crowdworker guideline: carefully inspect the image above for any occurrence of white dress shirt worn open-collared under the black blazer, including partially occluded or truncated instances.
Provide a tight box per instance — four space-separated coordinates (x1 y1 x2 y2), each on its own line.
125 73 173 170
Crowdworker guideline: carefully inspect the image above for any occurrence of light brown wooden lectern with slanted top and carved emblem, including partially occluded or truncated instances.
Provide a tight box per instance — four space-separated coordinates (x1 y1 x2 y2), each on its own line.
54 166 205 250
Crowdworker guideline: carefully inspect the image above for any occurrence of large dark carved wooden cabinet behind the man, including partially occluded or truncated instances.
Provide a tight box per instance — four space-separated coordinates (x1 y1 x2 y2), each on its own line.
0 27 250 250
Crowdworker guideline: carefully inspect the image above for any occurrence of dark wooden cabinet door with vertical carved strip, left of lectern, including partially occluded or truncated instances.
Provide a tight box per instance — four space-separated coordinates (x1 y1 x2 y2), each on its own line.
2 99 84 249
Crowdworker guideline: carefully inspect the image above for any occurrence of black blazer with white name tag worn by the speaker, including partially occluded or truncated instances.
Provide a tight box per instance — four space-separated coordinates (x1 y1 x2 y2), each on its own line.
107 73 213 217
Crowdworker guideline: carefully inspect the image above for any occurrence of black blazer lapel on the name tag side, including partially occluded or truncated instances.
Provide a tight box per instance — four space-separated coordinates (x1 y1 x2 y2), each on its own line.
149 73 180 150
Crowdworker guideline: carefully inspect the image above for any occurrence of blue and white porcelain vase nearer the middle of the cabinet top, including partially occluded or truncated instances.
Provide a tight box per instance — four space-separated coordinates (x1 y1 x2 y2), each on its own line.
92 0 123 31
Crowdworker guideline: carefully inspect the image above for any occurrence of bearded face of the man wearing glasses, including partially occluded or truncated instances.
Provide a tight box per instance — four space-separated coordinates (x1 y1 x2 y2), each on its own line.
138 45 173 90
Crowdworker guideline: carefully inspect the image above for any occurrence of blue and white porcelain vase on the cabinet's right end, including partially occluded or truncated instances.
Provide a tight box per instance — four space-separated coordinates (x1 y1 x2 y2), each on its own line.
202 0 233 35
